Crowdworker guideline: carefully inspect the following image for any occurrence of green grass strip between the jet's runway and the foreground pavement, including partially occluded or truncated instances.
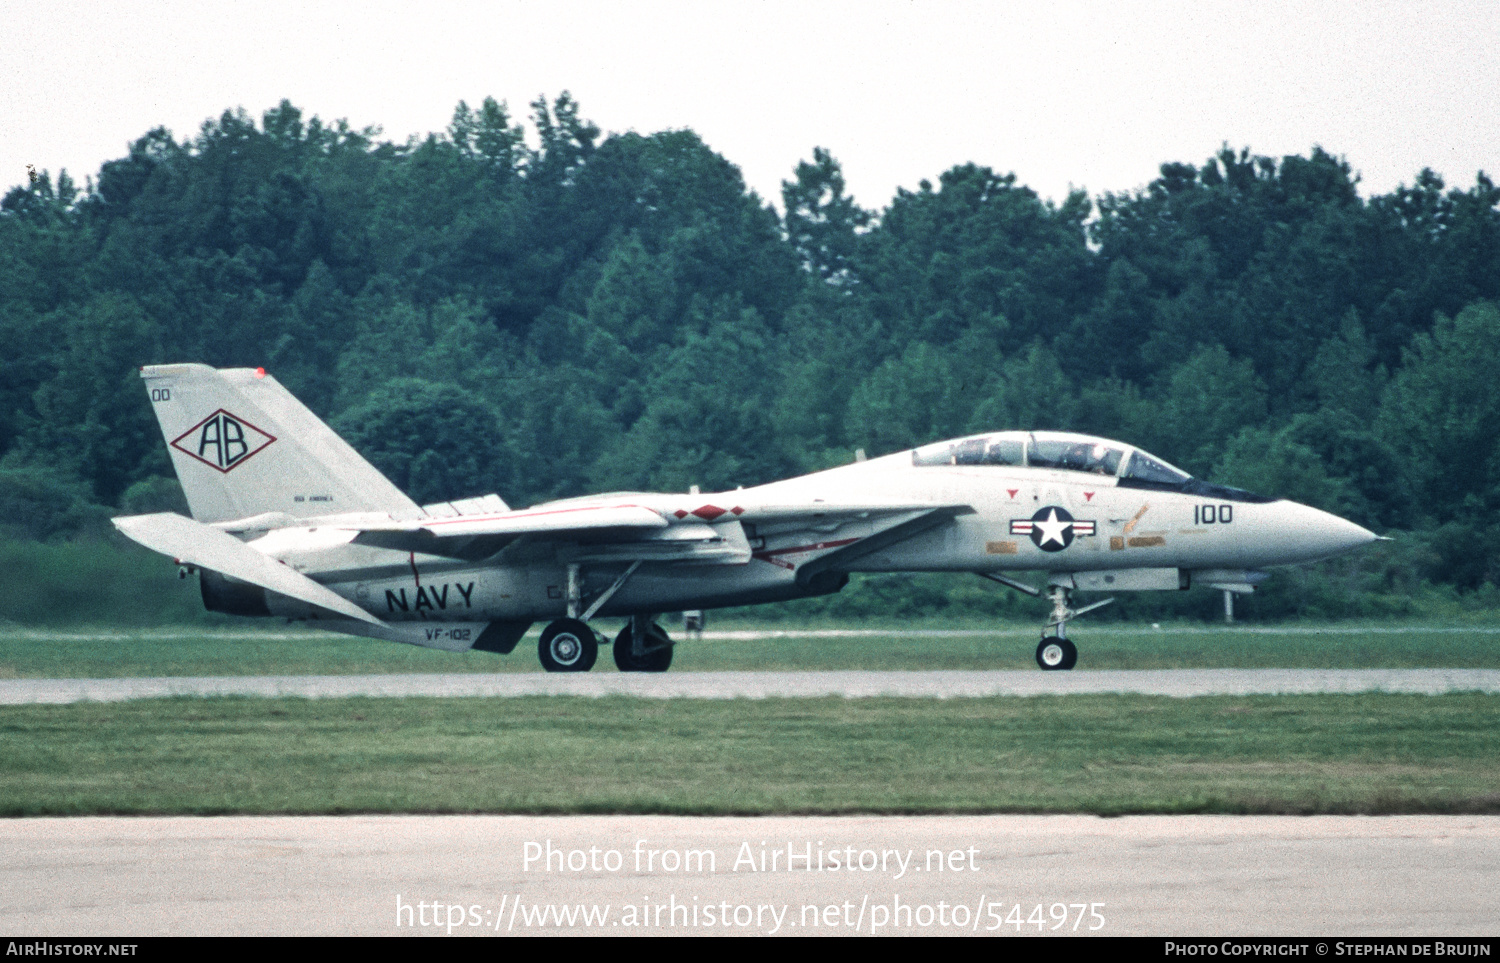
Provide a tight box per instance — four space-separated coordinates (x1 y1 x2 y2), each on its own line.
0 695 1500 816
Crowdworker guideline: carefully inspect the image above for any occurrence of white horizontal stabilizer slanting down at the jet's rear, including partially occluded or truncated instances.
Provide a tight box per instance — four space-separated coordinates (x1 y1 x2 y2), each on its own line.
113 512 386 626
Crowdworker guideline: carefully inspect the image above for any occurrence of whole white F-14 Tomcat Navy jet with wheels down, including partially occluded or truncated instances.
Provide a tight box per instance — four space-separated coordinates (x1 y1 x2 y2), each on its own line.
114 365 1376 672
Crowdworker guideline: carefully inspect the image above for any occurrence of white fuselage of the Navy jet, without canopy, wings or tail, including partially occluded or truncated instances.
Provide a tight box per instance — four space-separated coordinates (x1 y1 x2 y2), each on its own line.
258 441 1373 621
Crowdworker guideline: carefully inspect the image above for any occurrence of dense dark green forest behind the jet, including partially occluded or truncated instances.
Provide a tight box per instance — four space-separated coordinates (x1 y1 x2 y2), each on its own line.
0 93 1500 618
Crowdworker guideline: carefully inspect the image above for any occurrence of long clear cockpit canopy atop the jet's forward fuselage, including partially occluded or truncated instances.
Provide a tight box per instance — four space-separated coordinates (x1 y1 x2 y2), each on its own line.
912 432 1275 501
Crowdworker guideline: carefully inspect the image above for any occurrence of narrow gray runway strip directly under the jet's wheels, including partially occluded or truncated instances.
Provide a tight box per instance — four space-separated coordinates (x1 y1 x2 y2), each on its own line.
0 669 1500 705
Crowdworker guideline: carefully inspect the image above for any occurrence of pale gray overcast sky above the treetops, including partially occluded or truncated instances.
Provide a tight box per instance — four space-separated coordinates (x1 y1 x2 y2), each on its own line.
0 0 1500 209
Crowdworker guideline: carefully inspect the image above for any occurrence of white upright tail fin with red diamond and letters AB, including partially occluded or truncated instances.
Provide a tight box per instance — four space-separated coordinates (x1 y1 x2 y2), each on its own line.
141 365 422 522
